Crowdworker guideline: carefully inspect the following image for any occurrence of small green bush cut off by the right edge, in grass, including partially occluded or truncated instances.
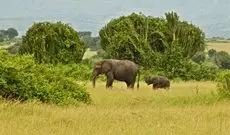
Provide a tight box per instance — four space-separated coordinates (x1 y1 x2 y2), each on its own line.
216 70 230 98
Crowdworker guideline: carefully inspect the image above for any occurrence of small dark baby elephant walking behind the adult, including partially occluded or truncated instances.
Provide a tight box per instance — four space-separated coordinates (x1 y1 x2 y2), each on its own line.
145 76 170 90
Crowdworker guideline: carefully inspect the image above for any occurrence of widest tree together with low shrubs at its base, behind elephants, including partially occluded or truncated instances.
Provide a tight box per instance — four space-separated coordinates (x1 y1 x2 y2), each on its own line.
99 12 217 80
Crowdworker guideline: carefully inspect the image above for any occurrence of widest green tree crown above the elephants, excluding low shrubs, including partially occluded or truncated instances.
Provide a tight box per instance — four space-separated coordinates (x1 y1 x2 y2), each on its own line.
99 12 205 65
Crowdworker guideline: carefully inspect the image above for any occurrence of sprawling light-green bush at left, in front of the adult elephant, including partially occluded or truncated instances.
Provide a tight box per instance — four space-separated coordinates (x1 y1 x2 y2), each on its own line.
0 51 91 105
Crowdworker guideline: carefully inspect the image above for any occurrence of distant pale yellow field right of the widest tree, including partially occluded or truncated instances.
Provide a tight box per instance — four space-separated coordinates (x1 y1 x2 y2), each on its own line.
207 42 230 53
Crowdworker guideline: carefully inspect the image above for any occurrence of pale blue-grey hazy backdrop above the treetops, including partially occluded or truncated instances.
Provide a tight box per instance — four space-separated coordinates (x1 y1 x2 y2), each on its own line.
0 0 230 37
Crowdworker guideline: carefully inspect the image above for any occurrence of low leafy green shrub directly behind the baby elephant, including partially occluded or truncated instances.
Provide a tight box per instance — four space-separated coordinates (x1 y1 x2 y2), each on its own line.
144 50 219 81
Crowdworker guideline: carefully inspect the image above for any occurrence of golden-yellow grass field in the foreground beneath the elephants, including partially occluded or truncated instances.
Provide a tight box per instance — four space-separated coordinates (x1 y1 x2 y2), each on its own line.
0 82 230 135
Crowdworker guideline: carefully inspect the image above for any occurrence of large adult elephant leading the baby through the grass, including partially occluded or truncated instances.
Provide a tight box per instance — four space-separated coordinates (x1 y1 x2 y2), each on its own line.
92 59 140 89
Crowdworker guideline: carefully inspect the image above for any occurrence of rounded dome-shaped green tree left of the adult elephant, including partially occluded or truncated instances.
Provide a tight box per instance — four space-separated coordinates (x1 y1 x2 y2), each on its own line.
19 22 86 64
